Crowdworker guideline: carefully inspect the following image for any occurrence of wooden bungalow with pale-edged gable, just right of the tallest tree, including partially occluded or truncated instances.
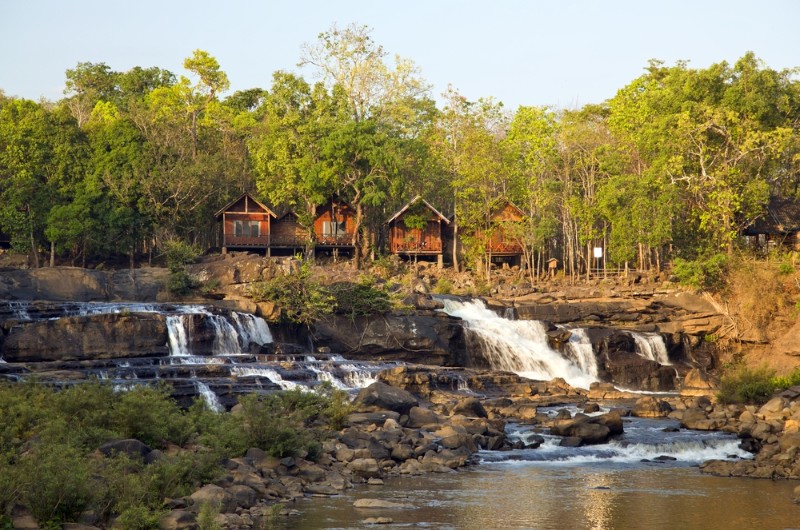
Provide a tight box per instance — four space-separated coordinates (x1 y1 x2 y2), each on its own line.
386 195 450 267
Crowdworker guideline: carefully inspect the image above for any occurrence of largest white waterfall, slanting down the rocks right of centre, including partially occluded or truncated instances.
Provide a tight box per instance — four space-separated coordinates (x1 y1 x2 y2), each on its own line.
444 299 597 388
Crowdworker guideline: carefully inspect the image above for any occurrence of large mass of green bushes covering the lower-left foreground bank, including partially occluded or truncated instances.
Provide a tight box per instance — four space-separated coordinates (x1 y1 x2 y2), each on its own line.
0 383 352 529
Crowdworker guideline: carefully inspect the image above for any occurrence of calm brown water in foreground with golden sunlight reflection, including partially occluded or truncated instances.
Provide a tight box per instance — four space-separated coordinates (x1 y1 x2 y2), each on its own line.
284 464 800 530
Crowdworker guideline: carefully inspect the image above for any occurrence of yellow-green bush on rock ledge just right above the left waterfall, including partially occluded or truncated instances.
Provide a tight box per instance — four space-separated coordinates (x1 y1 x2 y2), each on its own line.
249 262 335 325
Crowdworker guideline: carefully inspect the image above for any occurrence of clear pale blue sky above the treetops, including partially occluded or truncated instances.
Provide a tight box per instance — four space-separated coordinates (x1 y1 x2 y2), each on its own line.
0 0 800 109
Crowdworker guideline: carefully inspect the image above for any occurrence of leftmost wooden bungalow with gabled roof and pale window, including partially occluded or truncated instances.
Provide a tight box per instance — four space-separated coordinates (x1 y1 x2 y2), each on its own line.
215 192 275 254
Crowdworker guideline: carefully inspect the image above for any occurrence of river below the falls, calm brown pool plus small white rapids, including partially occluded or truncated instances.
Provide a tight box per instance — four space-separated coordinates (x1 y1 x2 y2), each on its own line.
280 409 800 530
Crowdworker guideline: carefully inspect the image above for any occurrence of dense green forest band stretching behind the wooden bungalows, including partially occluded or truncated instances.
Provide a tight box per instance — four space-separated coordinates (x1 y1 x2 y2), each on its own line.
0 25 800 274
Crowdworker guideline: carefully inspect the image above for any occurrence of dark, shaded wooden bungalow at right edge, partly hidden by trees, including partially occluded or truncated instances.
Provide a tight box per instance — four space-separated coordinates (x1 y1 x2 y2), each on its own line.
743 197 800 250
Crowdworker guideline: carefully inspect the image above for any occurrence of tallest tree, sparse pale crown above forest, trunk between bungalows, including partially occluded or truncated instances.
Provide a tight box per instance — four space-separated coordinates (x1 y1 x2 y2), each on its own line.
300 25 429 267
